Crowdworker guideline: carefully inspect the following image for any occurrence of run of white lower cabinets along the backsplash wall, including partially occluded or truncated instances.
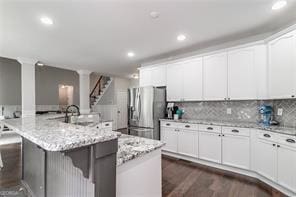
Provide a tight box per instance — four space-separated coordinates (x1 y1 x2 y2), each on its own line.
161 122 296 193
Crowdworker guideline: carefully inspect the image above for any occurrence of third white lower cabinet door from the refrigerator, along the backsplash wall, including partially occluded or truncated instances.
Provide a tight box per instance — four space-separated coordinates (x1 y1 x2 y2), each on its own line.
198 131 221 163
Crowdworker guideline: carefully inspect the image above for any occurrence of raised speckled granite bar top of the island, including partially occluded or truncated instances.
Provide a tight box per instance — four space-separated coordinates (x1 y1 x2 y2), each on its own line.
1 114 120 151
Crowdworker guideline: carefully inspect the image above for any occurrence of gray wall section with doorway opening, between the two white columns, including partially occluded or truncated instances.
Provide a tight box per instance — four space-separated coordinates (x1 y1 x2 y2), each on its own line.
36 66 79 105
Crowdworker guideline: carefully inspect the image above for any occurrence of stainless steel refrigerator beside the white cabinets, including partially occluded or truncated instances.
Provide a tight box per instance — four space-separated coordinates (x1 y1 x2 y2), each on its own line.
128 87 166 140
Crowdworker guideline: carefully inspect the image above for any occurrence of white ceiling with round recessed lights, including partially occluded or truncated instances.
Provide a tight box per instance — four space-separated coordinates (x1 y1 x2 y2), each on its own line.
0 0 296 76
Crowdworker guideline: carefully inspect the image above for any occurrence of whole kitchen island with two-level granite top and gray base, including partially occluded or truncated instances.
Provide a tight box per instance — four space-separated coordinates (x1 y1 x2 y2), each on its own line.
2 115 163 197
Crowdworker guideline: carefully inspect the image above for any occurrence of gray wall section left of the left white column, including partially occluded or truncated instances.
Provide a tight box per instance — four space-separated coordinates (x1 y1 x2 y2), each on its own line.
0 57 22 105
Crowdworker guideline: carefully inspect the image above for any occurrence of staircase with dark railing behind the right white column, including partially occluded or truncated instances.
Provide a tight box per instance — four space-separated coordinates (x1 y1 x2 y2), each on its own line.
89 76 113 109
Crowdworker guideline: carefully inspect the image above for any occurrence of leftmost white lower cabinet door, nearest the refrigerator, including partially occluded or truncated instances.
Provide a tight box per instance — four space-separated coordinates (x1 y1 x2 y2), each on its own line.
161 127 178 153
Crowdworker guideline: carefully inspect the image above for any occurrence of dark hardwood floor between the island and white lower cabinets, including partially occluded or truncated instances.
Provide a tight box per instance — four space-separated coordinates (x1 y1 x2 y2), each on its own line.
162 156 285 197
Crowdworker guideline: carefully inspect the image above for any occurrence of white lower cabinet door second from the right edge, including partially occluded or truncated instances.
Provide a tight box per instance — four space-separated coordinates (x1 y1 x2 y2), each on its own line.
256 139 277 181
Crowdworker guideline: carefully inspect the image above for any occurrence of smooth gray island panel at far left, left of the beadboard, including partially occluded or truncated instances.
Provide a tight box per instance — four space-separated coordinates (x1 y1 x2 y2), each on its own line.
22 138 46 197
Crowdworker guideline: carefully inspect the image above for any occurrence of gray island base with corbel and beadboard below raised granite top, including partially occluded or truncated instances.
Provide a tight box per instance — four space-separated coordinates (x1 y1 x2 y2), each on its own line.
22 138 118 197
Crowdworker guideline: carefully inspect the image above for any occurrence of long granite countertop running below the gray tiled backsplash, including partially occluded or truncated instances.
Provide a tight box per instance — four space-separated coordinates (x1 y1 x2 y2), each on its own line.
160 119 296 136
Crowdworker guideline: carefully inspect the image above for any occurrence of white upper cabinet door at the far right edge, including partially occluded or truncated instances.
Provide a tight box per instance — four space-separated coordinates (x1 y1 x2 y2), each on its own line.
268 32 296 98
